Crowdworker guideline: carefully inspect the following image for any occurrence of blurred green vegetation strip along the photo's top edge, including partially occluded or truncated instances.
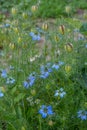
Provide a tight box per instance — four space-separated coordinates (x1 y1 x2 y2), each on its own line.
0 0 87 18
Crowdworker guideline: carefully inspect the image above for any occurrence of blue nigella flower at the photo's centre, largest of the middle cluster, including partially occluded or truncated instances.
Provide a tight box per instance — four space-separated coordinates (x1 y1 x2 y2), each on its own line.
40 63 52 79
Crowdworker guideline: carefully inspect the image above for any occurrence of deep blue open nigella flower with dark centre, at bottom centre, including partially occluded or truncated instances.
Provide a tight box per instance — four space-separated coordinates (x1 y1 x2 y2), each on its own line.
39 105 54 118
